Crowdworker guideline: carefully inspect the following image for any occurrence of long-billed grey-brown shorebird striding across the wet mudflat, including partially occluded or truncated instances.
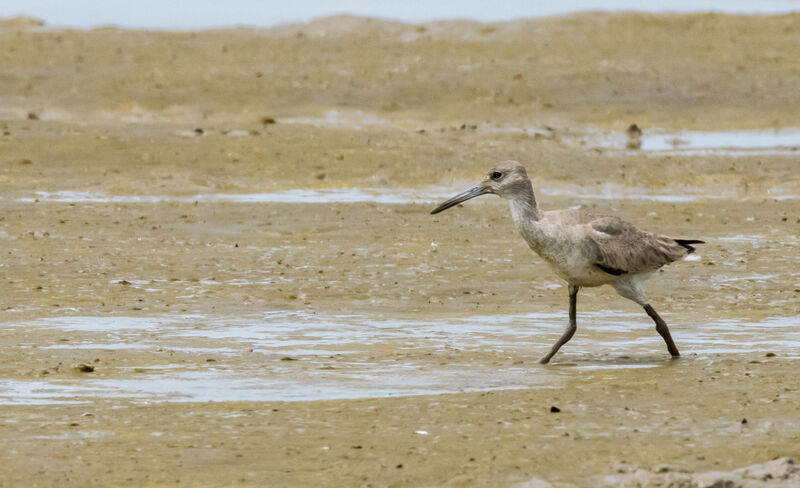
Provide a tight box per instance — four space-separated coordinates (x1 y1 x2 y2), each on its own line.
431 161 704 364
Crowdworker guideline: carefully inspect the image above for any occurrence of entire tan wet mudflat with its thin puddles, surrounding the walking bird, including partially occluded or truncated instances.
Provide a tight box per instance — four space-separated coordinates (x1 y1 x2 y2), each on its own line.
0 10 800 486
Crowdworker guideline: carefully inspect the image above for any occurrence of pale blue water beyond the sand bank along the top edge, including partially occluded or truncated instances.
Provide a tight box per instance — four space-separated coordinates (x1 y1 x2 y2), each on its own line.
8 0 797 29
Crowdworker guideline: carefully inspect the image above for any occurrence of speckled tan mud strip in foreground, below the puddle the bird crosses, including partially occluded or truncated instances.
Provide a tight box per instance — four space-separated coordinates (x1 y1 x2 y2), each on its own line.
0 356 800 486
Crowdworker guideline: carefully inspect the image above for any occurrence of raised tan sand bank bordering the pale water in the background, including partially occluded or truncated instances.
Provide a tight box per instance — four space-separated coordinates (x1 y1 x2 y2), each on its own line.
0 12 800 129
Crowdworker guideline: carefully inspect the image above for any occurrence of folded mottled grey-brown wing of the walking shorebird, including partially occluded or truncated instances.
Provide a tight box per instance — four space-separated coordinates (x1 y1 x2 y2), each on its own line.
586 216 687 275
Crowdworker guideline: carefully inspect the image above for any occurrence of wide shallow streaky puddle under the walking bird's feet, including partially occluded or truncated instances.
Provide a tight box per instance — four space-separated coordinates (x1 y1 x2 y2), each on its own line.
0 311 800 404
